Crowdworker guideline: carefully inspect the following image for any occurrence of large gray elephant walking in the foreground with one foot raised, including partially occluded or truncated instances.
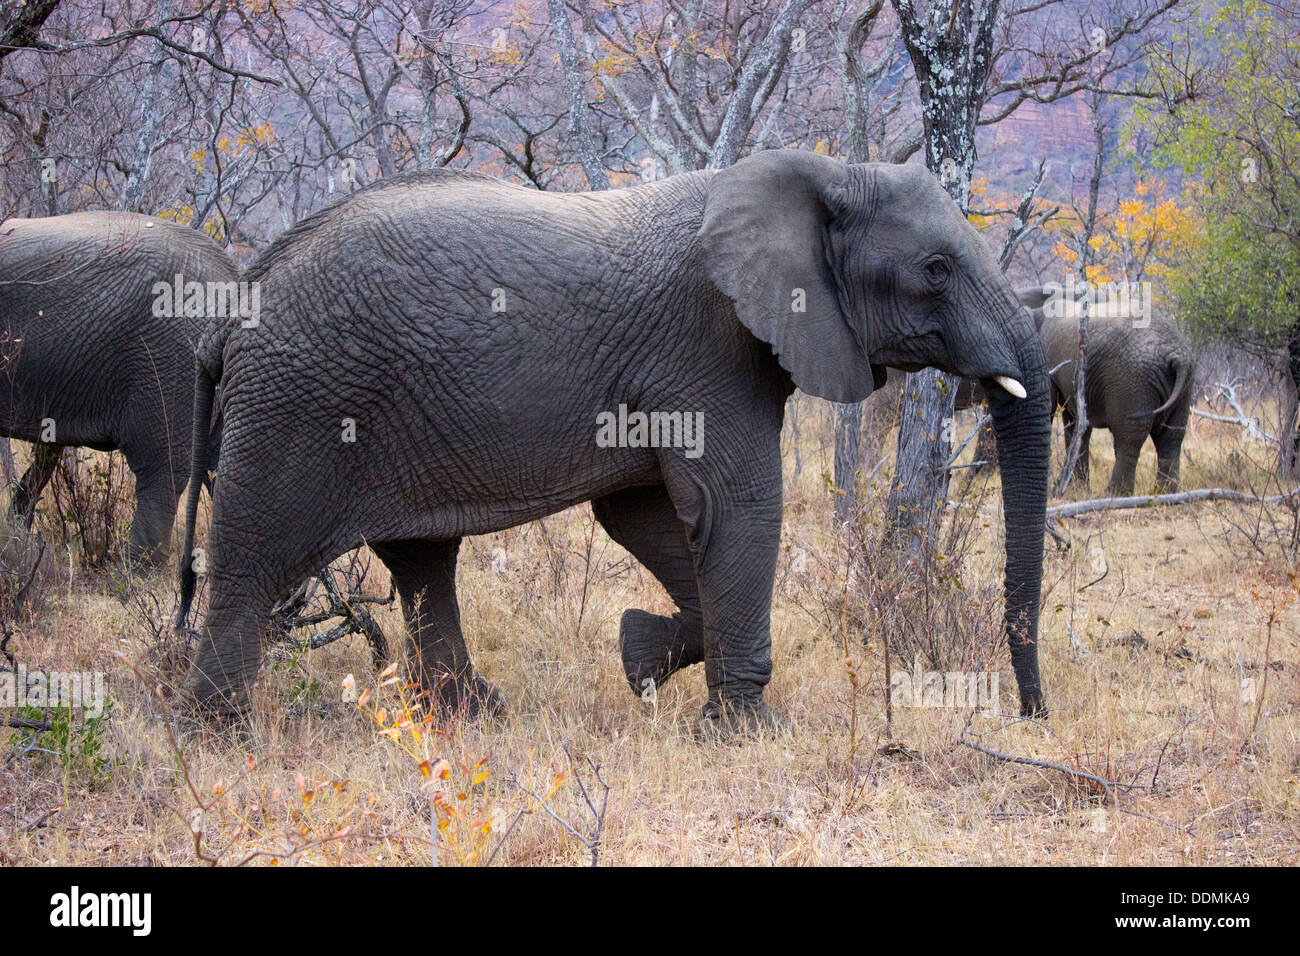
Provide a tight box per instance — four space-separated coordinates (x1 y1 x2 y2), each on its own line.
181 151 1048 734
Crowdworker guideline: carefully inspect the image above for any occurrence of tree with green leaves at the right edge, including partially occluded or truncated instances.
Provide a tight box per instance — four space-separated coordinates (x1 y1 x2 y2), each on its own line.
1135 0 1300 470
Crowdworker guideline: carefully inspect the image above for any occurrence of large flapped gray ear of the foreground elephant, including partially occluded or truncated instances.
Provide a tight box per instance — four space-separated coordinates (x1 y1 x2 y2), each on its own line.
699 150 884 402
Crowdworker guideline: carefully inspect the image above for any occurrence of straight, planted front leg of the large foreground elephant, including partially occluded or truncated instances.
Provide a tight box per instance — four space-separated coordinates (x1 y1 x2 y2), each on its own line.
666 458 788 737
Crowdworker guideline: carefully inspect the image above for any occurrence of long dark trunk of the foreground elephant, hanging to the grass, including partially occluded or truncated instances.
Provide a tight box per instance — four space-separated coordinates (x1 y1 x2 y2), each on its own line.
988 313 1052 717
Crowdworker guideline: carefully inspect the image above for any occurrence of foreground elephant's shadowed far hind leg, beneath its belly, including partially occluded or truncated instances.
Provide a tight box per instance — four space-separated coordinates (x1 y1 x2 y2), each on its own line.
371 537 506 718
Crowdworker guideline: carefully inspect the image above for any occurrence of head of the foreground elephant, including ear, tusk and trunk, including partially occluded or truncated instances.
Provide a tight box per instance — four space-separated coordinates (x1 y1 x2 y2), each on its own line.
699 151 1049 713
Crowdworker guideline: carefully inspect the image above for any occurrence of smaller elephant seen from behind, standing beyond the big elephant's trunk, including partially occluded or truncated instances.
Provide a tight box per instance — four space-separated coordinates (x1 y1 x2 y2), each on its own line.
1034 293 1196 496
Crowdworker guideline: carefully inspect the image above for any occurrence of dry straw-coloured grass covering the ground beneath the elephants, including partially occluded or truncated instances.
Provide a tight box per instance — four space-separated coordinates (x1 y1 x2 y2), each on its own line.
0 402 1300 865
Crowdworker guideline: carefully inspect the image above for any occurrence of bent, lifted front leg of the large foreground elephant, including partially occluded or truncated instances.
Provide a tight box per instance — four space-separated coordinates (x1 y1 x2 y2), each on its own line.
592 485 705 693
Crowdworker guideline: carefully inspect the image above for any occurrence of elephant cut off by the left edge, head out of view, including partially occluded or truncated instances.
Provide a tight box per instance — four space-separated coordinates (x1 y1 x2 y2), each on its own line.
0 212 238 566
